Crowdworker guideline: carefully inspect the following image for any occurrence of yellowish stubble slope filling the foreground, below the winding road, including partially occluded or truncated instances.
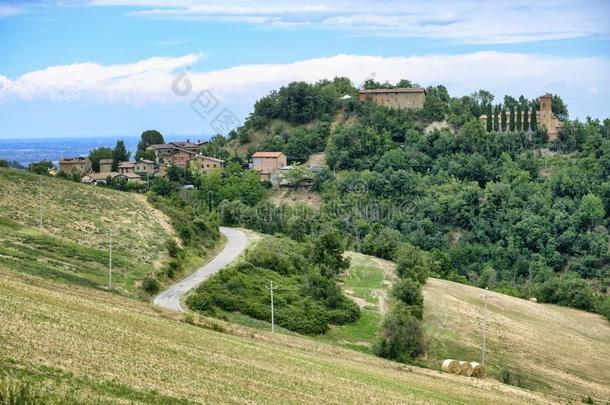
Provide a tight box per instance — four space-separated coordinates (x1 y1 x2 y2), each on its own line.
0 266 552 404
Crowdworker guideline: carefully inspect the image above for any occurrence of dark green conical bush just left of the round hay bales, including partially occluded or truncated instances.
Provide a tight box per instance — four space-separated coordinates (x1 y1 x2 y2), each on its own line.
374 302 425 363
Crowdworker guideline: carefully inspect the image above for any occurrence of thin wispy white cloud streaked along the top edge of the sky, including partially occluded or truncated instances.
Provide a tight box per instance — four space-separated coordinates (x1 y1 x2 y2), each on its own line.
82 0 610 44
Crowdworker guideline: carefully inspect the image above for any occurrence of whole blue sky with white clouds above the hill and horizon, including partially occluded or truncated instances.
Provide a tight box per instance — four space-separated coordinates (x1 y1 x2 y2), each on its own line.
0 0 610 139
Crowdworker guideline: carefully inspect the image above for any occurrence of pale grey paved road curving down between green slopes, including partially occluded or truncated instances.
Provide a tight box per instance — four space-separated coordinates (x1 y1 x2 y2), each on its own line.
155 226 248 311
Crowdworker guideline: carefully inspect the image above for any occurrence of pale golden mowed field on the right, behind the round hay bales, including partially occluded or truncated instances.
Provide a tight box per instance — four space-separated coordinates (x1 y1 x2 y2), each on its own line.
424 279 610 403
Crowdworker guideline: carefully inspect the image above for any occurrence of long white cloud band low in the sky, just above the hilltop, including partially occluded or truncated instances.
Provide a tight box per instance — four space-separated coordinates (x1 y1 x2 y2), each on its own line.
0 52 610 116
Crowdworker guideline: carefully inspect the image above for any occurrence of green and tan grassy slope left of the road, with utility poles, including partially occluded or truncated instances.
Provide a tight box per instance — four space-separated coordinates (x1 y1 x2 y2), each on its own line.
0 169 173 294
